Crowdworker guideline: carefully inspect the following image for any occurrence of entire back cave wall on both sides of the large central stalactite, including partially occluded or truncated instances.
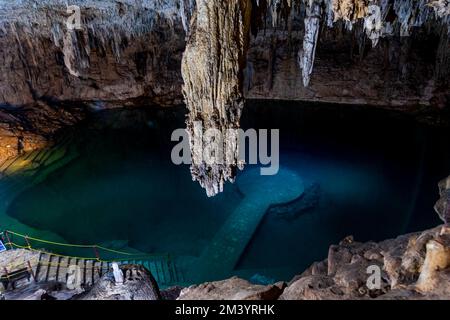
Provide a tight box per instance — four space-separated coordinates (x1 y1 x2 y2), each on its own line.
0 0 450 107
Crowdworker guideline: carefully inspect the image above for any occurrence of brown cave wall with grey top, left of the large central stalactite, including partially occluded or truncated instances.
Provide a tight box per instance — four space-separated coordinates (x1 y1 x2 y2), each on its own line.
0 0 187 106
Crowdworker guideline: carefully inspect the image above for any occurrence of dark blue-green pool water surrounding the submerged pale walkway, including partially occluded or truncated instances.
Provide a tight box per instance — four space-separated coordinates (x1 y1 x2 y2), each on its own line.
0 101 450 283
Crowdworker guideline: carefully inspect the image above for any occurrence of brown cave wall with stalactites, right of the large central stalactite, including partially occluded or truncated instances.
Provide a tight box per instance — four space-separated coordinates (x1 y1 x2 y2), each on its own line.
245 0 450 108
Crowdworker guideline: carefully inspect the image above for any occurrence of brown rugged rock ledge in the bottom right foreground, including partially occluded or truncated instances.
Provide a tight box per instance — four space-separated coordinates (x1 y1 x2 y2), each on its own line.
178 227 450 300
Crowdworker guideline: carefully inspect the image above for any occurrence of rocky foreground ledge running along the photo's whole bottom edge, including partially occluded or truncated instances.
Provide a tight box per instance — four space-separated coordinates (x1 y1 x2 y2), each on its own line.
0 222 450 300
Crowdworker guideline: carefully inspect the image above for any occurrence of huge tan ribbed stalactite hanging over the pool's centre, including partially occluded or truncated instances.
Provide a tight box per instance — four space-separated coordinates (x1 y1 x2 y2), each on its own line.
182 0 252 196
